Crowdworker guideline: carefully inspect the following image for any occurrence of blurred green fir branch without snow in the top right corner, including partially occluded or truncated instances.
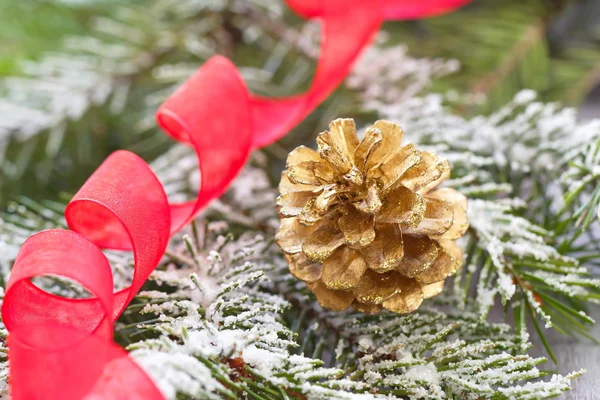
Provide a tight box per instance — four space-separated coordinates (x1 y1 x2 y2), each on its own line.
382 0 600 111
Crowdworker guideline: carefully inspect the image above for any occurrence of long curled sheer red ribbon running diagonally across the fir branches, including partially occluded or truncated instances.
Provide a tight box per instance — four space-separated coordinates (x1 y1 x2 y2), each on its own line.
2 0 468 400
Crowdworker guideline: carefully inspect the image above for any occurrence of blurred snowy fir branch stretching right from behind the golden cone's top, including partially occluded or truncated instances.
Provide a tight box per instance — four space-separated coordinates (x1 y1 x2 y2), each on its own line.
364 90 600 179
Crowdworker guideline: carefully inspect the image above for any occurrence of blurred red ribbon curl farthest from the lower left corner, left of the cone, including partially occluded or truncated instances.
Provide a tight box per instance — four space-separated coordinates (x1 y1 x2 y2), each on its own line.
156 56 254 233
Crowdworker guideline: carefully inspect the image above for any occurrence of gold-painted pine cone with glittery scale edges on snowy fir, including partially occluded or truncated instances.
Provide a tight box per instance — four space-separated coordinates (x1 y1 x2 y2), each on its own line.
275 119 469 313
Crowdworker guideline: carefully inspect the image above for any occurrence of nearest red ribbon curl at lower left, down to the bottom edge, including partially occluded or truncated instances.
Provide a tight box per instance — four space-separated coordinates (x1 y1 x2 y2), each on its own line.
3 230 114 399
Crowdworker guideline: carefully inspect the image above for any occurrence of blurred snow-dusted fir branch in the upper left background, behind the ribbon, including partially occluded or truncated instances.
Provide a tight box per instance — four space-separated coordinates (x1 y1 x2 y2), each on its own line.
0 0 292 141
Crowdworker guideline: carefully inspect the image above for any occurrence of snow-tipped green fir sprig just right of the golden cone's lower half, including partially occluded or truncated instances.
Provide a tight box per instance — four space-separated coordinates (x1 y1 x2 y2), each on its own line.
465 199 600 332
